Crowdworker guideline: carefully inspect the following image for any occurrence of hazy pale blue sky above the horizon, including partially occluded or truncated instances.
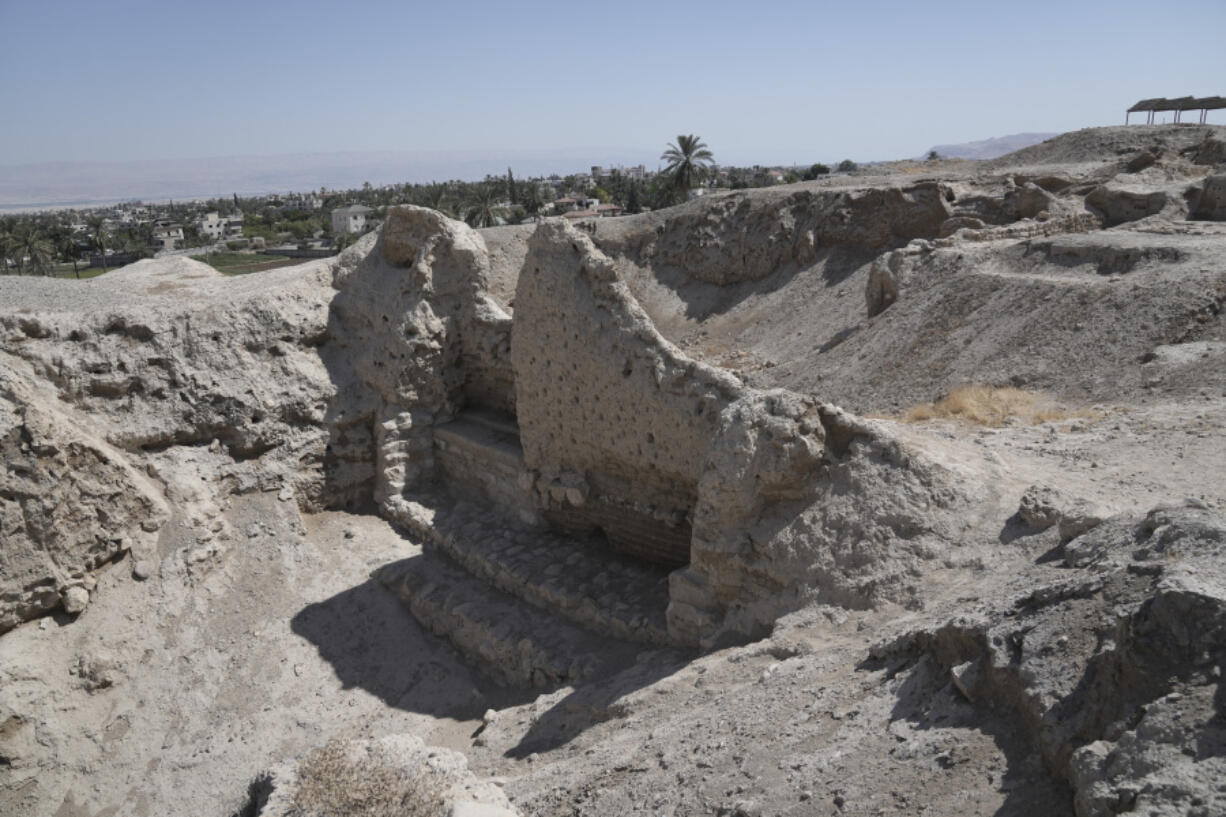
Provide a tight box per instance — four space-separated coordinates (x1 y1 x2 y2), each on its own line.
0 0 1226 166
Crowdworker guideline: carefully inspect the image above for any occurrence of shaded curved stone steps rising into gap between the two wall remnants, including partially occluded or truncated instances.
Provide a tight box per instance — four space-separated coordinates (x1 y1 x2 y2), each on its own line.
376 411 671 687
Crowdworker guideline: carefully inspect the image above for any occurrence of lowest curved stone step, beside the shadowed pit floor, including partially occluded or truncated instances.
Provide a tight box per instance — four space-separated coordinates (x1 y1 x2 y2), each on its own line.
375 553 642 687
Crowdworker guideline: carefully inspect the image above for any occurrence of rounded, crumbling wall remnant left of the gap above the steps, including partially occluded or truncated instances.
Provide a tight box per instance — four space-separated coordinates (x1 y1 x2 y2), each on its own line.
331 206 515 509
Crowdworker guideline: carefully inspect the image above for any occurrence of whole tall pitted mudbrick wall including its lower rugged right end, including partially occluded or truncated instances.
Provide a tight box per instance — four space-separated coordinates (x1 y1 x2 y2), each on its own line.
511 222 964 645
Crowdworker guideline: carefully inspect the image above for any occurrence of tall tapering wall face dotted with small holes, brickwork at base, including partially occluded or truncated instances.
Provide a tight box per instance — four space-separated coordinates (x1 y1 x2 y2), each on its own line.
511 221 744 564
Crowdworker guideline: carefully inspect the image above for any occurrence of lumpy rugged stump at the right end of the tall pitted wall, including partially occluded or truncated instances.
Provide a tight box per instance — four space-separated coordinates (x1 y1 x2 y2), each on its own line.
668 390 966 645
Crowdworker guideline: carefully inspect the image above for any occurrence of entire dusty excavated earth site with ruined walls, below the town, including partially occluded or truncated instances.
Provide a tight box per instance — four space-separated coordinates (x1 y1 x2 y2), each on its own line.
0 125 1226 817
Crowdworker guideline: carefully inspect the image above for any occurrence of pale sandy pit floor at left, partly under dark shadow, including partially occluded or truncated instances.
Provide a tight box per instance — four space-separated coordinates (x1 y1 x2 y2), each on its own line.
0 494 507 817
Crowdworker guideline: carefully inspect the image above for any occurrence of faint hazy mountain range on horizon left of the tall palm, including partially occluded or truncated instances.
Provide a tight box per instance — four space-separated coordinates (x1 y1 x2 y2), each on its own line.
0 147 658 210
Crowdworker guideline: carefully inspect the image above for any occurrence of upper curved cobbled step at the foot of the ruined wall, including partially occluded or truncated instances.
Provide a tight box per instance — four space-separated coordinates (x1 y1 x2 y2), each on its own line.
389 494 672 645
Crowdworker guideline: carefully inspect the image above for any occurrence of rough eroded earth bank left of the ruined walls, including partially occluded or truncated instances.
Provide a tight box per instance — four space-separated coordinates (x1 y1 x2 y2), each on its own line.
0 259 343 626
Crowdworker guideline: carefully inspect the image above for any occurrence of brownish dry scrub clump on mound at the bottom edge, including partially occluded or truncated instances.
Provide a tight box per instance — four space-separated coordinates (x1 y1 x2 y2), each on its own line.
292 740 450 817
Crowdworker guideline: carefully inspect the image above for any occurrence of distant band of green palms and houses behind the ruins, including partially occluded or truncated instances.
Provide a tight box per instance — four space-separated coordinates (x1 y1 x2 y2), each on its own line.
0 142 882 278
